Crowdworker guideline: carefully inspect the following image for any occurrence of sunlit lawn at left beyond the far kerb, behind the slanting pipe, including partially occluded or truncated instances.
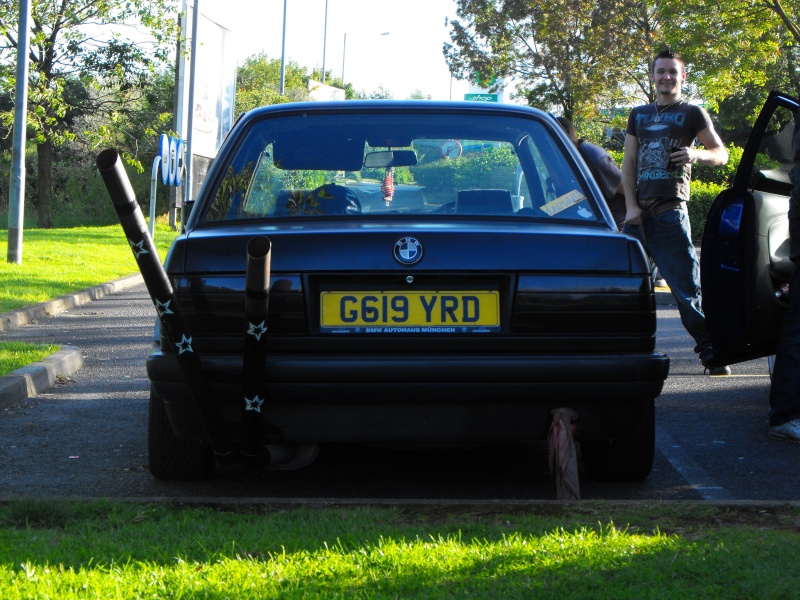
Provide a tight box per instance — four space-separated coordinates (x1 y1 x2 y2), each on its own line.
0 222 177 313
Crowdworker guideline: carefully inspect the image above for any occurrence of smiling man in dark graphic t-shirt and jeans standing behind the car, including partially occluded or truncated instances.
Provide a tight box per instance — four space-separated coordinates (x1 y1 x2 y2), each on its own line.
622 48 730 375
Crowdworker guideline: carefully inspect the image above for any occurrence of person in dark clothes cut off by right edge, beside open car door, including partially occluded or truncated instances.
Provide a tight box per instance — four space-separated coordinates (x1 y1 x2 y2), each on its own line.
769 115 800 442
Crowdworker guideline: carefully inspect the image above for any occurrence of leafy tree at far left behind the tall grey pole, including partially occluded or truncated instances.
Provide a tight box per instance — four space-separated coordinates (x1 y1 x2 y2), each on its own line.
0 0 178 228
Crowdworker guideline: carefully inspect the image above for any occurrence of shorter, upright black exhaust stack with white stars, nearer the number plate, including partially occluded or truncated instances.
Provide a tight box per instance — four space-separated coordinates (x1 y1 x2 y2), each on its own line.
241 236 272 466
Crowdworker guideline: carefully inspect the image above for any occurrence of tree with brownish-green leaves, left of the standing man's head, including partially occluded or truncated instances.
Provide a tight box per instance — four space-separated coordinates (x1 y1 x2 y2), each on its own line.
444 0 640 118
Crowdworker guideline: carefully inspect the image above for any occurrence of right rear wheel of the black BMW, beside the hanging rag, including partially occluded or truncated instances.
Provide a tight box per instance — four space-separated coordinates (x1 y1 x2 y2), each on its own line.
581 398 656 481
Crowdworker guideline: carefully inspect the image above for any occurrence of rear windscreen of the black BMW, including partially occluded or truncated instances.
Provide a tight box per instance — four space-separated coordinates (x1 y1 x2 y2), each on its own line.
198 113 602 222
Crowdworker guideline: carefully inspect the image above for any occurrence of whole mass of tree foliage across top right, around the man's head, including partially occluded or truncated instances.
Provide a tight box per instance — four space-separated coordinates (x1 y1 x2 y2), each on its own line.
444 0 800 126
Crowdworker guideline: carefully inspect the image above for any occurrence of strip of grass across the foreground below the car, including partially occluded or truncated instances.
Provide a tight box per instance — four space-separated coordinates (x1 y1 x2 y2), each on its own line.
0 500 800 600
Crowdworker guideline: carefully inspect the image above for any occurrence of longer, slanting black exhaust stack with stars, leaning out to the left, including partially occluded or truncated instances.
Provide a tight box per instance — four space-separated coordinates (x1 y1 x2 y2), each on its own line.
97 149 237 463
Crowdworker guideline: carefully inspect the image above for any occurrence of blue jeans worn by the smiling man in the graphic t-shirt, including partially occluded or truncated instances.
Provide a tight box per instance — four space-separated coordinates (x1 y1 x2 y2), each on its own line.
623 202 710 352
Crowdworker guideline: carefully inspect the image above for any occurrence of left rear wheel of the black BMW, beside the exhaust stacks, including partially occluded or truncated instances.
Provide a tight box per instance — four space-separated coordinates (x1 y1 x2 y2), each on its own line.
147 390 215 481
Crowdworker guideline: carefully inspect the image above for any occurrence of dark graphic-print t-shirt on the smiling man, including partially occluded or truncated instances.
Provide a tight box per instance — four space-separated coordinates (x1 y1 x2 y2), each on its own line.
625 101 712 200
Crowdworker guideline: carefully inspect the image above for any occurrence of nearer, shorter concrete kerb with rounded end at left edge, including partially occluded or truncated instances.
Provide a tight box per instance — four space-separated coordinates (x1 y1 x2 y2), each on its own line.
0 346 83 408
